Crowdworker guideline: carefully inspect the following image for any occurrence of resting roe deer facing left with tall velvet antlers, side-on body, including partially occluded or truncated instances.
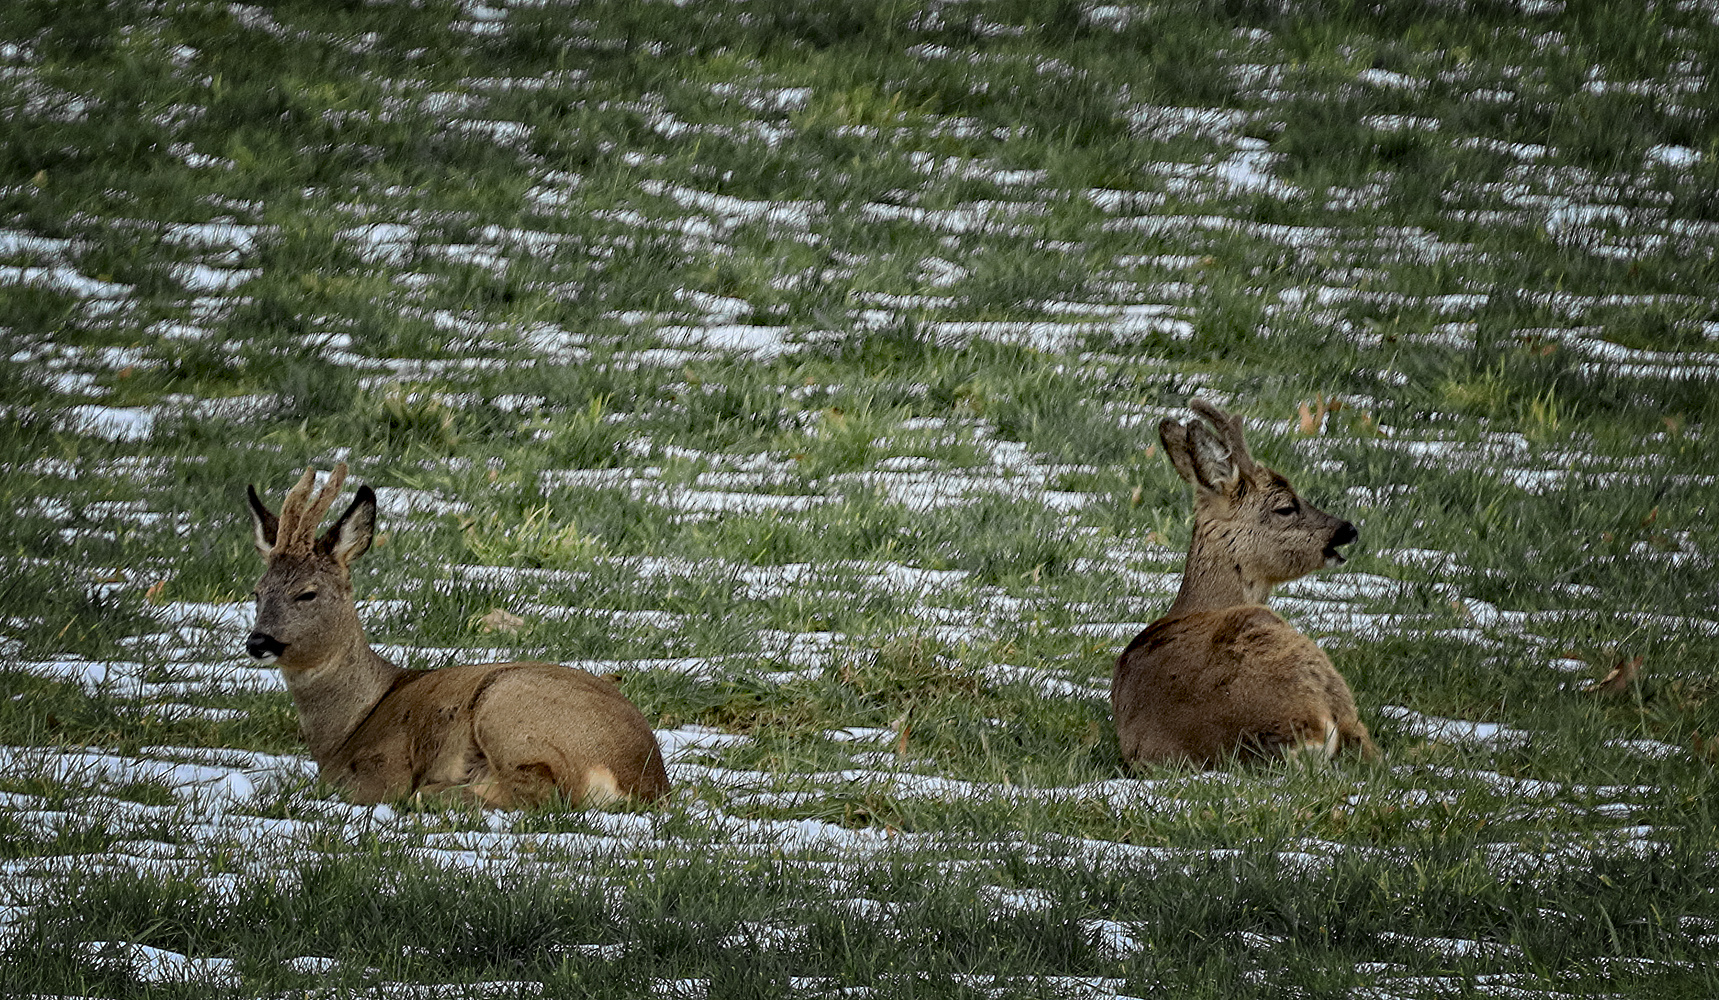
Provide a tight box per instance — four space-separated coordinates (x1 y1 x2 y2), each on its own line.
246 464 669 808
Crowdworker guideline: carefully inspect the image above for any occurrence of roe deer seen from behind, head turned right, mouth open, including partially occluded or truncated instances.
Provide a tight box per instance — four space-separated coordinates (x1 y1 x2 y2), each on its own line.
1110 399 1379 766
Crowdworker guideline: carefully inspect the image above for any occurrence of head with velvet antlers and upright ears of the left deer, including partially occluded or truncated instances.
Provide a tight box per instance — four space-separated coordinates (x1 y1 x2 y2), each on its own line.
244 462 376 674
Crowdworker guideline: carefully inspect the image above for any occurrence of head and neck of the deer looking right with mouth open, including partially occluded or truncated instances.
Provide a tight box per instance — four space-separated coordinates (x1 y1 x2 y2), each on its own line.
1159 399 1358 610
